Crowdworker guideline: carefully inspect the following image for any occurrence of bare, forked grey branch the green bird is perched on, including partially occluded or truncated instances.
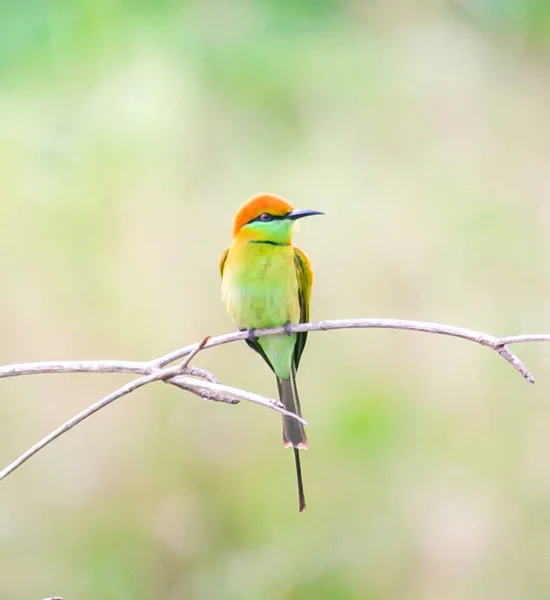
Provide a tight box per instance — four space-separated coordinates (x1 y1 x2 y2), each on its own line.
0 319 550 480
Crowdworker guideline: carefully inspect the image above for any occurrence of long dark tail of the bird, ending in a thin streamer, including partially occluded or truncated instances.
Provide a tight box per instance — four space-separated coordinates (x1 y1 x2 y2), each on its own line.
277 367 307 512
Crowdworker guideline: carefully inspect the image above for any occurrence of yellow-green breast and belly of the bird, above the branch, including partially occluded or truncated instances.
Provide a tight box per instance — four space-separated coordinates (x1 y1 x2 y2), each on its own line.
222 242 300 329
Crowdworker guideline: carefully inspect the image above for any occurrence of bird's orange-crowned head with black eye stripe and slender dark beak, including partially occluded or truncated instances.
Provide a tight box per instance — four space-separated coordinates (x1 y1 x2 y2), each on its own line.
233 194 323 245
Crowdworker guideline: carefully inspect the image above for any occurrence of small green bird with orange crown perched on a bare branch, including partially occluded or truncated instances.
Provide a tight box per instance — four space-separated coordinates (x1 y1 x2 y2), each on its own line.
219 194 324 512
